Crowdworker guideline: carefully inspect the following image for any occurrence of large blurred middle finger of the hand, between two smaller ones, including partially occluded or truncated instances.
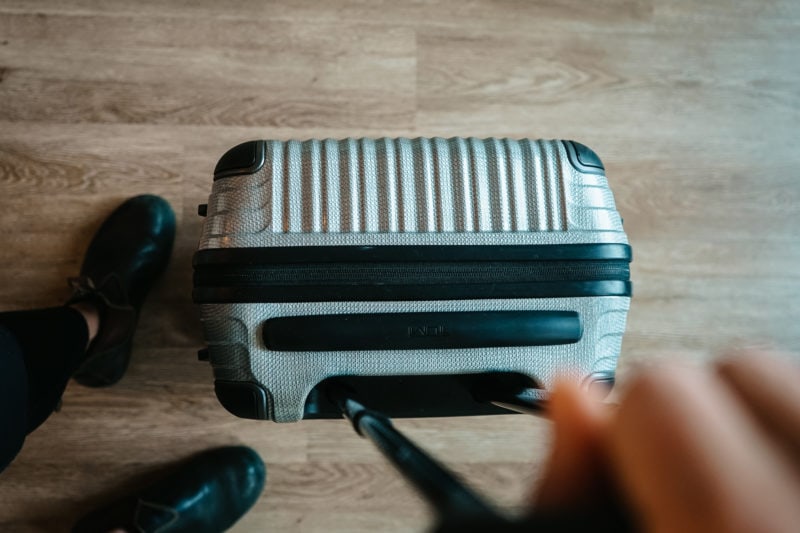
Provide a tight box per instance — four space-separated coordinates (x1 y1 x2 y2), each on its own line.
606 367 800 532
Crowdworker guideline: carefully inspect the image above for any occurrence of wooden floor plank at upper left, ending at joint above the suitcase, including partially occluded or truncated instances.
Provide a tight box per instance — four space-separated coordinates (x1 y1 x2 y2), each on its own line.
0 15 415 128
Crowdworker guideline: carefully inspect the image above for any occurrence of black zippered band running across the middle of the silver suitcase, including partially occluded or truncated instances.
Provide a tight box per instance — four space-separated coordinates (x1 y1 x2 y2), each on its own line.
193 244 631 303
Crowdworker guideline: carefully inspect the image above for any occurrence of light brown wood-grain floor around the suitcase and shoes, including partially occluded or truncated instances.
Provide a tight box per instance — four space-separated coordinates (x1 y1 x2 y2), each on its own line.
0 0 800 532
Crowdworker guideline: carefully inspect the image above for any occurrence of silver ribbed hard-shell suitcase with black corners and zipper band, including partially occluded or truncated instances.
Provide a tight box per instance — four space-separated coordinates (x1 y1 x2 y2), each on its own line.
193 138 631 422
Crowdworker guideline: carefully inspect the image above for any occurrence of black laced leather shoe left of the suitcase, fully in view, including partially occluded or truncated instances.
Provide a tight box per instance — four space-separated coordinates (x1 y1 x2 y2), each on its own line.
67 195 175 387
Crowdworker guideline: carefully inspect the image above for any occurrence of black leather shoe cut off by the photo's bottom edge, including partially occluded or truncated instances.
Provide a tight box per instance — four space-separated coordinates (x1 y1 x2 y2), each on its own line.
72 446 266 533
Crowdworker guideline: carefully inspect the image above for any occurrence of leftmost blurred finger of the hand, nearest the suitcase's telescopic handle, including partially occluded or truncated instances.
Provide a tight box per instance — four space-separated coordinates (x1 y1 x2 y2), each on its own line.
534 381 607 509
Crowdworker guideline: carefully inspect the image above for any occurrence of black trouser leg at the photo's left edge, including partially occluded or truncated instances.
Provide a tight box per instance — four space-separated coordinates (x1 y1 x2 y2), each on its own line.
0 307 89 471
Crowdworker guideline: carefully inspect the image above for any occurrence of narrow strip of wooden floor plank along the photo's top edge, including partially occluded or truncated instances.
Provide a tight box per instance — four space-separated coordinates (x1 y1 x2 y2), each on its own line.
0 0 654 31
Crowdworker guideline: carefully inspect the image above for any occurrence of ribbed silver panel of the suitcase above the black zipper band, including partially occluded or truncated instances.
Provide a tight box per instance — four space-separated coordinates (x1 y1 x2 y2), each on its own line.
208 138 592 235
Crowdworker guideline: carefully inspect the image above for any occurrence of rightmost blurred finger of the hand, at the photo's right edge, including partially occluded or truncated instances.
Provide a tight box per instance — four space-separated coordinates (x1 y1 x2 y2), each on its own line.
718 352 800 460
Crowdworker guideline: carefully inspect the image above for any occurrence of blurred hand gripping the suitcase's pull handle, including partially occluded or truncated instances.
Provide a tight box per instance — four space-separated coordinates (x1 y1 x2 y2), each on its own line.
535 352 800 533
